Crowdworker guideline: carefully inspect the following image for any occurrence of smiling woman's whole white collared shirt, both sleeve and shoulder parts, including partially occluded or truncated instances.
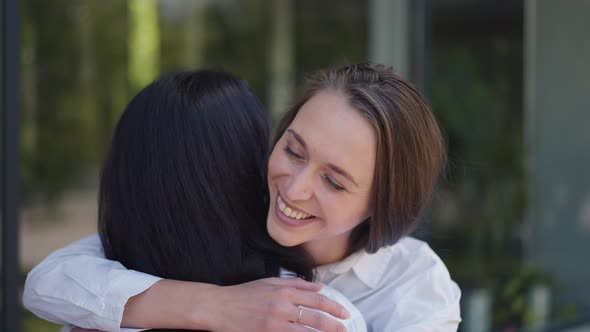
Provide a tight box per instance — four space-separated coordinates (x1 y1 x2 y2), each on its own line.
23 234 461 332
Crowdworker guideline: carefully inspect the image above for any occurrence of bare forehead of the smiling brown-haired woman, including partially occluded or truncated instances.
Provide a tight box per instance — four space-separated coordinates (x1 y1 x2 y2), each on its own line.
287 91 376 184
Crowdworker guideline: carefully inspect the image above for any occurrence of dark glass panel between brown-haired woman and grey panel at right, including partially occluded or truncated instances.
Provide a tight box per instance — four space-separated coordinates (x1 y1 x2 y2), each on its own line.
429 2 528 331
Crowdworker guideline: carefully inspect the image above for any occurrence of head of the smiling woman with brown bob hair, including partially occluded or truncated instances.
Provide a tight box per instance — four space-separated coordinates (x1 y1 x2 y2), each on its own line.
267 65 446 264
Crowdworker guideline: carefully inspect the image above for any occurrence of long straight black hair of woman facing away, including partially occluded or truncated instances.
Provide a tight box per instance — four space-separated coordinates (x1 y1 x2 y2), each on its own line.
99 70 312 298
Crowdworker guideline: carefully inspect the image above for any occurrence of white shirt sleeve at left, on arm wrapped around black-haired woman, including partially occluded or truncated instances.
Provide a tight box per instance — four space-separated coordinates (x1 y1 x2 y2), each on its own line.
23 234 161 332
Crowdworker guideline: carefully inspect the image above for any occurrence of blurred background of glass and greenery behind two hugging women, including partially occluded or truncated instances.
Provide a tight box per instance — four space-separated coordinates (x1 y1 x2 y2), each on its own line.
0 0 590 332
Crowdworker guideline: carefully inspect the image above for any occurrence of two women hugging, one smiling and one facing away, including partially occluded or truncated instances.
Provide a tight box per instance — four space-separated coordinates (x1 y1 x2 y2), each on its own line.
23 64 461 332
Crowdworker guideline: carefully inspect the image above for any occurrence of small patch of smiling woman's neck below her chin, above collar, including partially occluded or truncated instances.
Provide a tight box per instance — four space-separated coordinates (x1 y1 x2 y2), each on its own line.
303 233 350 266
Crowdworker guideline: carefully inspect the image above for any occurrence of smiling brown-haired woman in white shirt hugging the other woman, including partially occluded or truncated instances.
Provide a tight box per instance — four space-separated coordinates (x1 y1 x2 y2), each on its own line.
28 64 460 331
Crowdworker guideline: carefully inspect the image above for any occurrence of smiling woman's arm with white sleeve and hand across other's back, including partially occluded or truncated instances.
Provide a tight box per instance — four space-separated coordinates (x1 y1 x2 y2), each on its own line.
23 234 352 331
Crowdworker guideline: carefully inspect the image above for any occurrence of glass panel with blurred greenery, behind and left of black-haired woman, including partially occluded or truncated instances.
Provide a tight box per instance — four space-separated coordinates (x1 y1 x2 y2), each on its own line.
20 0 367 331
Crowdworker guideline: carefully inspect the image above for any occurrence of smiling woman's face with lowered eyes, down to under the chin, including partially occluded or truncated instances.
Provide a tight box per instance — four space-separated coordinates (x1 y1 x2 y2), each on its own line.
267 91 376 264
